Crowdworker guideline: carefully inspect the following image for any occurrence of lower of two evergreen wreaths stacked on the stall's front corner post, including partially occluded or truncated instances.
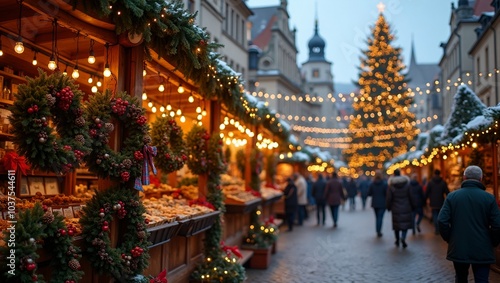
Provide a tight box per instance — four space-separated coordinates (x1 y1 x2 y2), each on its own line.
80 187 150 282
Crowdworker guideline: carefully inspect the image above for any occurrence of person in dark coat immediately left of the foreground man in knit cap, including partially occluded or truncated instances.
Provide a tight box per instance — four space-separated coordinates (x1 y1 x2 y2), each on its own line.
425 169 450 235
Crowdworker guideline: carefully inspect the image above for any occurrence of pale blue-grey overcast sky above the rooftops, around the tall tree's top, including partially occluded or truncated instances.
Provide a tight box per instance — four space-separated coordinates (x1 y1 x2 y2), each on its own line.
247 0 457 83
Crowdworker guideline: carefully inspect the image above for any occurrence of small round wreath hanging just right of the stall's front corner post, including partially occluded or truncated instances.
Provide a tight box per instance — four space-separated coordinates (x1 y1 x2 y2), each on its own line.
151 117 187 174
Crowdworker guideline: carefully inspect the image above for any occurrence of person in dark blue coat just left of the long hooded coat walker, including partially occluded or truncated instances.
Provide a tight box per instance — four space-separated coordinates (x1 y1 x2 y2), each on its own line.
368 171 387 237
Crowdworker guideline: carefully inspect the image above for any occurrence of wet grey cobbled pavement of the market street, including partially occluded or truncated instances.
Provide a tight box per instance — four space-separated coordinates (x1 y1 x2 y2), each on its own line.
246 199 500 283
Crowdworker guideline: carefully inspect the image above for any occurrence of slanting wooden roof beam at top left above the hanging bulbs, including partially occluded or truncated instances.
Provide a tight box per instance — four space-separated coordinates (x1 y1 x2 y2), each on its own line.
23 0 118 45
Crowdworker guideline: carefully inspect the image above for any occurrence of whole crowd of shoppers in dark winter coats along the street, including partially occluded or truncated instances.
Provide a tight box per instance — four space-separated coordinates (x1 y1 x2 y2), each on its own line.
278 166 500 282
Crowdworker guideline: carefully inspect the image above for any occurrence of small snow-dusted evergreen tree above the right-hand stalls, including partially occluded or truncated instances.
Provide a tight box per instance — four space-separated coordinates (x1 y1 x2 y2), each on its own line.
441 84 486 145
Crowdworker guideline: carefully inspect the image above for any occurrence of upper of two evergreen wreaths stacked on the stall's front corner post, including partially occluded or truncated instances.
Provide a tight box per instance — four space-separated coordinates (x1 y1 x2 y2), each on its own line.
86 90 151 186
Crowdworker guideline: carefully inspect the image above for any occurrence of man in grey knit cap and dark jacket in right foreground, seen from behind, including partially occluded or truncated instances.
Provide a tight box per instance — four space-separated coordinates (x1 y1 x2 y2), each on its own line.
438 165 500 282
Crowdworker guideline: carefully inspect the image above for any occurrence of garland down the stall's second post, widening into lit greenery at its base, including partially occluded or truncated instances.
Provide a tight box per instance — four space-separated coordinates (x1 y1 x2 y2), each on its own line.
191 129 245 283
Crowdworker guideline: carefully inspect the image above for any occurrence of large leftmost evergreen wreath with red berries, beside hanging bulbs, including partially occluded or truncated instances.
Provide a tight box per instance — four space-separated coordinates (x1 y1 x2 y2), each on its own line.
9 69 90 174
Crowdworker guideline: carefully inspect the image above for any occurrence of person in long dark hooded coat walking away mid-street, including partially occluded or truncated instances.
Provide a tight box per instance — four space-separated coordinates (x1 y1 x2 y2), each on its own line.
386 169 413 248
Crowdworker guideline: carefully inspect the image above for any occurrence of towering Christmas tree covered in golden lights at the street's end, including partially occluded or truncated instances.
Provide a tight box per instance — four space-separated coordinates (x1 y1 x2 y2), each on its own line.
344 13 418 175
